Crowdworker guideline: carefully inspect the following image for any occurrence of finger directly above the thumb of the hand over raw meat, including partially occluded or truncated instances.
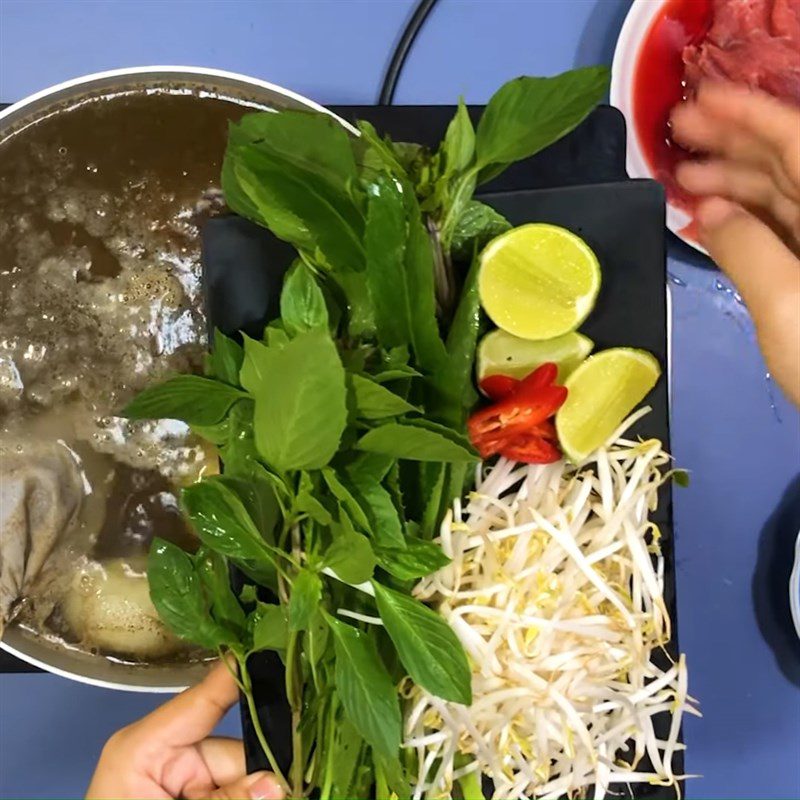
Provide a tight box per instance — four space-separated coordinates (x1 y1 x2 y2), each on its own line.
676 159 800 244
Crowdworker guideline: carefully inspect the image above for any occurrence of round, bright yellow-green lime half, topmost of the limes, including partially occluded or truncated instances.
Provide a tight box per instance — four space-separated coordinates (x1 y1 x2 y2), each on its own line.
478 223 600 339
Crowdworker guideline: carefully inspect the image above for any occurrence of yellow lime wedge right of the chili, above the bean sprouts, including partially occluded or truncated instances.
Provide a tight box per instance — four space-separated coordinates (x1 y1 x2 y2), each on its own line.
556 347 661 463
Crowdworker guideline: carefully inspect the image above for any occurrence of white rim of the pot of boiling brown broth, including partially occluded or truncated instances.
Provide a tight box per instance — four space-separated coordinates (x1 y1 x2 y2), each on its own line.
0 64 358 694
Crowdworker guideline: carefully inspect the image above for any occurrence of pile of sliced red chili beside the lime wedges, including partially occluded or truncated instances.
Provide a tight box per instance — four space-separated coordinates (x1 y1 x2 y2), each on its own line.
467 363 567 464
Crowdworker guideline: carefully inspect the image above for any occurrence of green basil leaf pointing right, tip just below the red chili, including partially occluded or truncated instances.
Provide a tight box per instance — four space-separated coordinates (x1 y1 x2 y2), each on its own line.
356 420 477 462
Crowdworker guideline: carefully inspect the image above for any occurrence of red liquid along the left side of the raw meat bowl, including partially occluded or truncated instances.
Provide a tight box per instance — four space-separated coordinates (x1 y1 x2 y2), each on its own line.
633 0 713 211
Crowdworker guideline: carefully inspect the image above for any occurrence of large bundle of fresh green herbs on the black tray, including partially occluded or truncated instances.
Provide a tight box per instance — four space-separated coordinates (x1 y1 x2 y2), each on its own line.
124 68 608 800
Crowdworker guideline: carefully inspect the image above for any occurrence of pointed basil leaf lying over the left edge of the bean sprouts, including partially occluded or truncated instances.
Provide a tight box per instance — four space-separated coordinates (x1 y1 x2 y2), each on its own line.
372 581 472 705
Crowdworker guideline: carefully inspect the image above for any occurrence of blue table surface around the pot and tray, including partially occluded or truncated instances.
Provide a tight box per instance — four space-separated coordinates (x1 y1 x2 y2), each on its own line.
0 0 800 798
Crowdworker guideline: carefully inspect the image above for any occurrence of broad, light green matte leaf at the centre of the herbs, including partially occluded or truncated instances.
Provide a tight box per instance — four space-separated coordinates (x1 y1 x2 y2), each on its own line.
241 330 347 472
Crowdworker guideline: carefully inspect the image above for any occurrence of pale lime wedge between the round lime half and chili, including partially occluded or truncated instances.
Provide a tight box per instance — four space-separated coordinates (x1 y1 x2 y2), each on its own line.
477 330 594 383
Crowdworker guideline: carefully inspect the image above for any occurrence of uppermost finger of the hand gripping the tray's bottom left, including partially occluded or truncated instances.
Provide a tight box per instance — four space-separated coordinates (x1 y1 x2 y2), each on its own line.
136 663 239 747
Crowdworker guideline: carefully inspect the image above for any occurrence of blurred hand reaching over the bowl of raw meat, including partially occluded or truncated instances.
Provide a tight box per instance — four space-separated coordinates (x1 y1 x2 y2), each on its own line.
672 83 800 404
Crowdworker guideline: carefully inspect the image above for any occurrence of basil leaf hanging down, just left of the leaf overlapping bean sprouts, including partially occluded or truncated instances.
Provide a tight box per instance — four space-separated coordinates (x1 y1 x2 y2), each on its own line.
326 615 401 757
